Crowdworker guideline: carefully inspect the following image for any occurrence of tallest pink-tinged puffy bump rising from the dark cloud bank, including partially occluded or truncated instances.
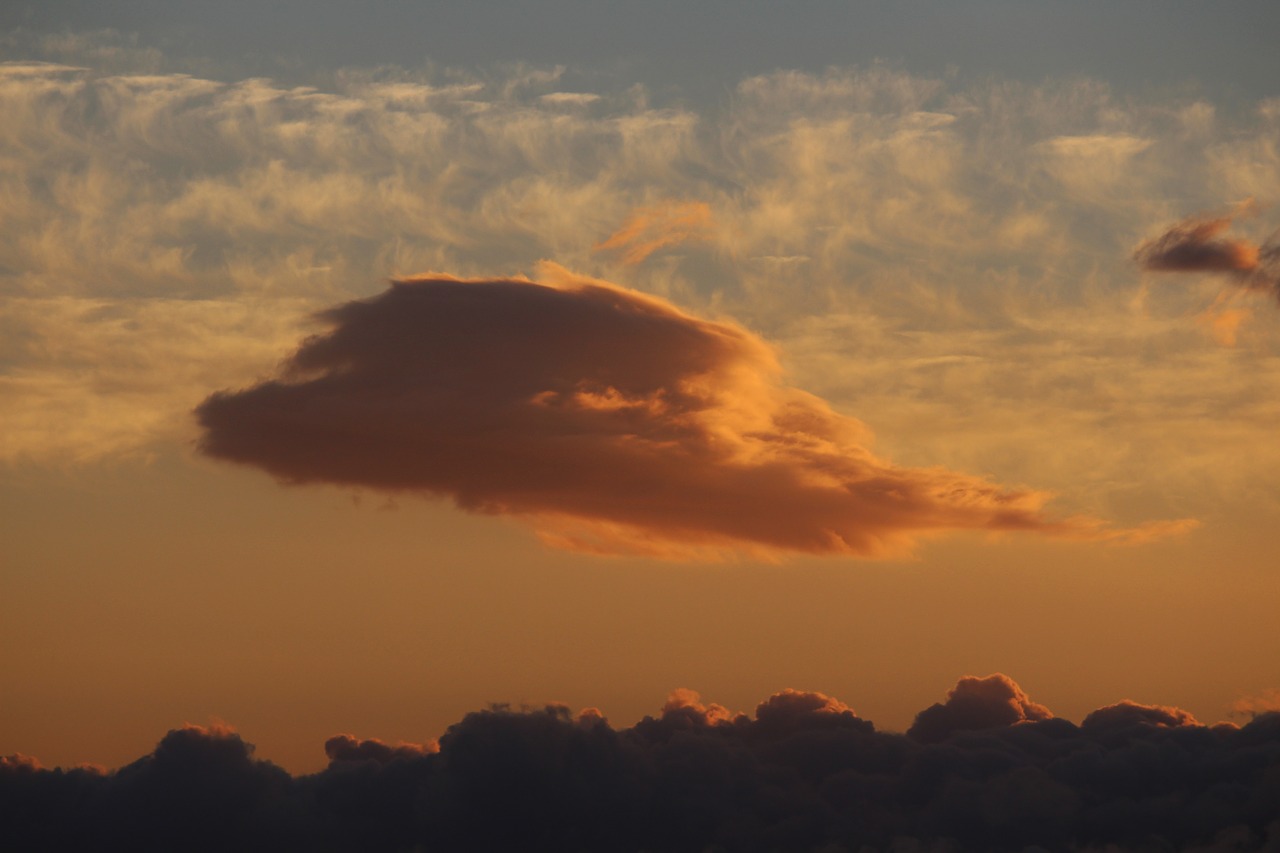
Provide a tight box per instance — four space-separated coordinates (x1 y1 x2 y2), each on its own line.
906 672 1053 743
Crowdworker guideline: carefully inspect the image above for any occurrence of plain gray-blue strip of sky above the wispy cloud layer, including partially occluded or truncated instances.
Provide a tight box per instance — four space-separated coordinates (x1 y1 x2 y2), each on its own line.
10 0 1280 102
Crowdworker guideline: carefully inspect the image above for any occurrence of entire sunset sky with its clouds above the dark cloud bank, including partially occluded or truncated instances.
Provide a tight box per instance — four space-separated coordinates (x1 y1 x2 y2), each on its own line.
0 1 1280 799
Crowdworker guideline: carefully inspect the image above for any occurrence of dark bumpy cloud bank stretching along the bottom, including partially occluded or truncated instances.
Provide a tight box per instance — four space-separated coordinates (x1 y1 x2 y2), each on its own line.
0 675 1280 853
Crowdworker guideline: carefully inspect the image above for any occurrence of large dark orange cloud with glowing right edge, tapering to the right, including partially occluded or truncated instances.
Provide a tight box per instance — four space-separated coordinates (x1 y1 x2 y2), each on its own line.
197 265 1182 557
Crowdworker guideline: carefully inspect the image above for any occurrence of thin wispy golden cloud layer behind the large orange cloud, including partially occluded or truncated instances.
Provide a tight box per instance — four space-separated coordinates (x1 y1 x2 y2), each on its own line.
0 51 1280 521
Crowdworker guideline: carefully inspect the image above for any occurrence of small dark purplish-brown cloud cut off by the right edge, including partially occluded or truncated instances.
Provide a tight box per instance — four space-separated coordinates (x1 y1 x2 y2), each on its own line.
1134 202 1280 298
